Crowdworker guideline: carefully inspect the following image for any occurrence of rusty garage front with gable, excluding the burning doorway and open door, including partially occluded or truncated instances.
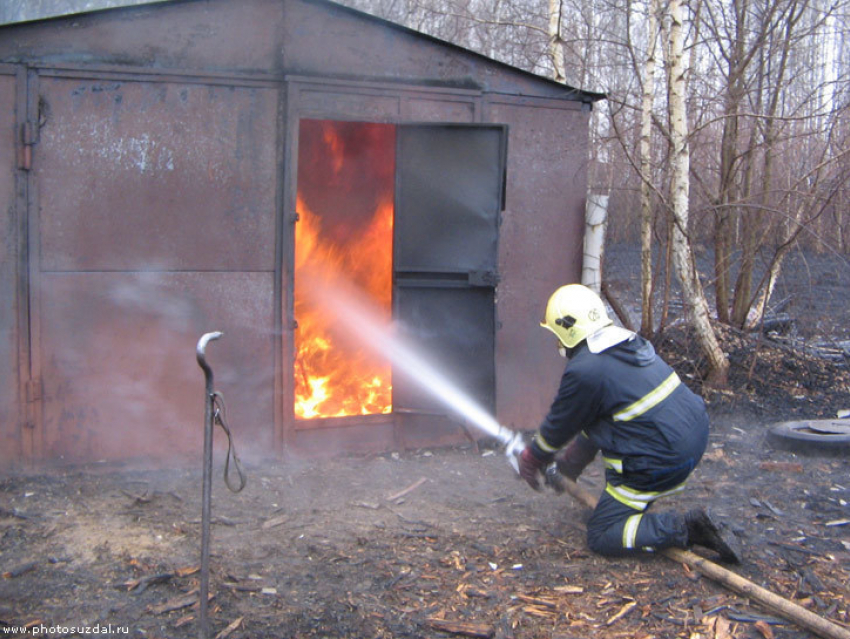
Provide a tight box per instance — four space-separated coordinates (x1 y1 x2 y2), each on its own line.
0 0 593 460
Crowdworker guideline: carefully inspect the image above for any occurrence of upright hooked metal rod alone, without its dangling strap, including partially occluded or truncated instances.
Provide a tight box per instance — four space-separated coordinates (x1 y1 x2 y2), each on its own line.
195 331 224 639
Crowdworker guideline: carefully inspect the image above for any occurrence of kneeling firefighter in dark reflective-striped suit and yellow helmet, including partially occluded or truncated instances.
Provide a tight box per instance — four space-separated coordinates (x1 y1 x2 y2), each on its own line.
519 284 740 563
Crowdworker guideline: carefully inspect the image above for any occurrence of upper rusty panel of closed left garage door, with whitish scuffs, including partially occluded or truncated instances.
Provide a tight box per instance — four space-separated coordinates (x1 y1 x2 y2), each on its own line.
36 77 277 272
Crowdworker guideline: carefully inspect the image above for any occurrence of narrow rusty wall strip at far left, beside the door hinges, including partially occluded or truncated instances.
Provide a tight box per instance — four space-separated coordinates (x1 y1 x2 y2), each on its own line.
0 66 21 465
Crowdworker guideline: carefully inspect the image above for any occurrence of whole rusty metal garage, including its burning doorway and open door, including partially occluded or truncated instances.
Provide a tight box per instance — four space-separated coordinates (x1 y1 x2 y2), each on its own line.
0 0 602 467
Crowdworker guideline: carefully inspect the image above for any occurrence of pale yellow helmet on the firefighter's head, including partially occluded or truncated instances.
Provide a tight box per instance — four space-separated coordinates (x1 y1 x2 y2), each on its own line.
540 284 613 348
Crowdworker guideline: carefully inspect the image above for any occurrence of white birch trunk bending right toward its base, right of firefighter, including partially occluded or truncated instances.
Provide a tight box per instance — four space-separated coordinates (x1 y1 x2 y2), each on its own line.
666 0 729 386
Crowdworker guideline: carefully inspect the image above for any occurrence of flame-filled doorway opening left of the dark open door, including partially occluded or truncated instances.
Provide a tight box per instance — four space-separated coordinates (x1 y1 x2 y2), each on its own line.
294 120 396 420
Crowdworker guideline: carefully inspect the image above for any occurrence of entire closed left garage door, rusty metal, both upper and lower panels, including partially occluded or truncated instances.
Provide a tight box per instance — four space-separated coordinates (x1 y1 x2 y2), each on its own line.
30 72 277 461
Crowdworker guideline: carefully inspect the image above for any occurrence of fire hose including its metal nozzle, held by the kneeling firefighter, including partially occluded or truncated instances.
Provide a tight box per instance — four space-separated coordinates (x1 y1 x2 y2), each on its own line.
497 438 850 639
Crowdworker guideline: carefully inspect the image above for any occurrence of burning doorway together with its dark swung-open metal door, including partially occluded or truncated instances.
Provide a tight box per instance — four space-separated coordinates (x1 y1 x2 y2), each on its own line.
292 119 507 441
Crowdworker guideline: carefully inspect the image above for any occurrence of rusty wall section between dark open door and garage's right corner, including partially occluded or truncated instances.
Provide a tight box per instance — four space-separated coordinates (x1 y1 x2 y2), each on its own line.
486 96 589 436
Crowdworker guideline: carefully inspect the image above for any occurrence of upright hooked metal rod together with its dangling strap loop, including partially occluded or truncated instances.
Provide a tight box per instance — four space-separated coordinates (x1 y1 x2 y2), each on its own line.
195 331 246 639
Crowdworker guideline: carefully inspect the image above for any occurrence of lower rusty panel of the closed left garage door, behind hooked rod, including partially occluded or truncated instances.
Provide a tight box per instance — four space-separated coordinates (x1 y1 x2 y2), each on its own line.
36 271 275 466
